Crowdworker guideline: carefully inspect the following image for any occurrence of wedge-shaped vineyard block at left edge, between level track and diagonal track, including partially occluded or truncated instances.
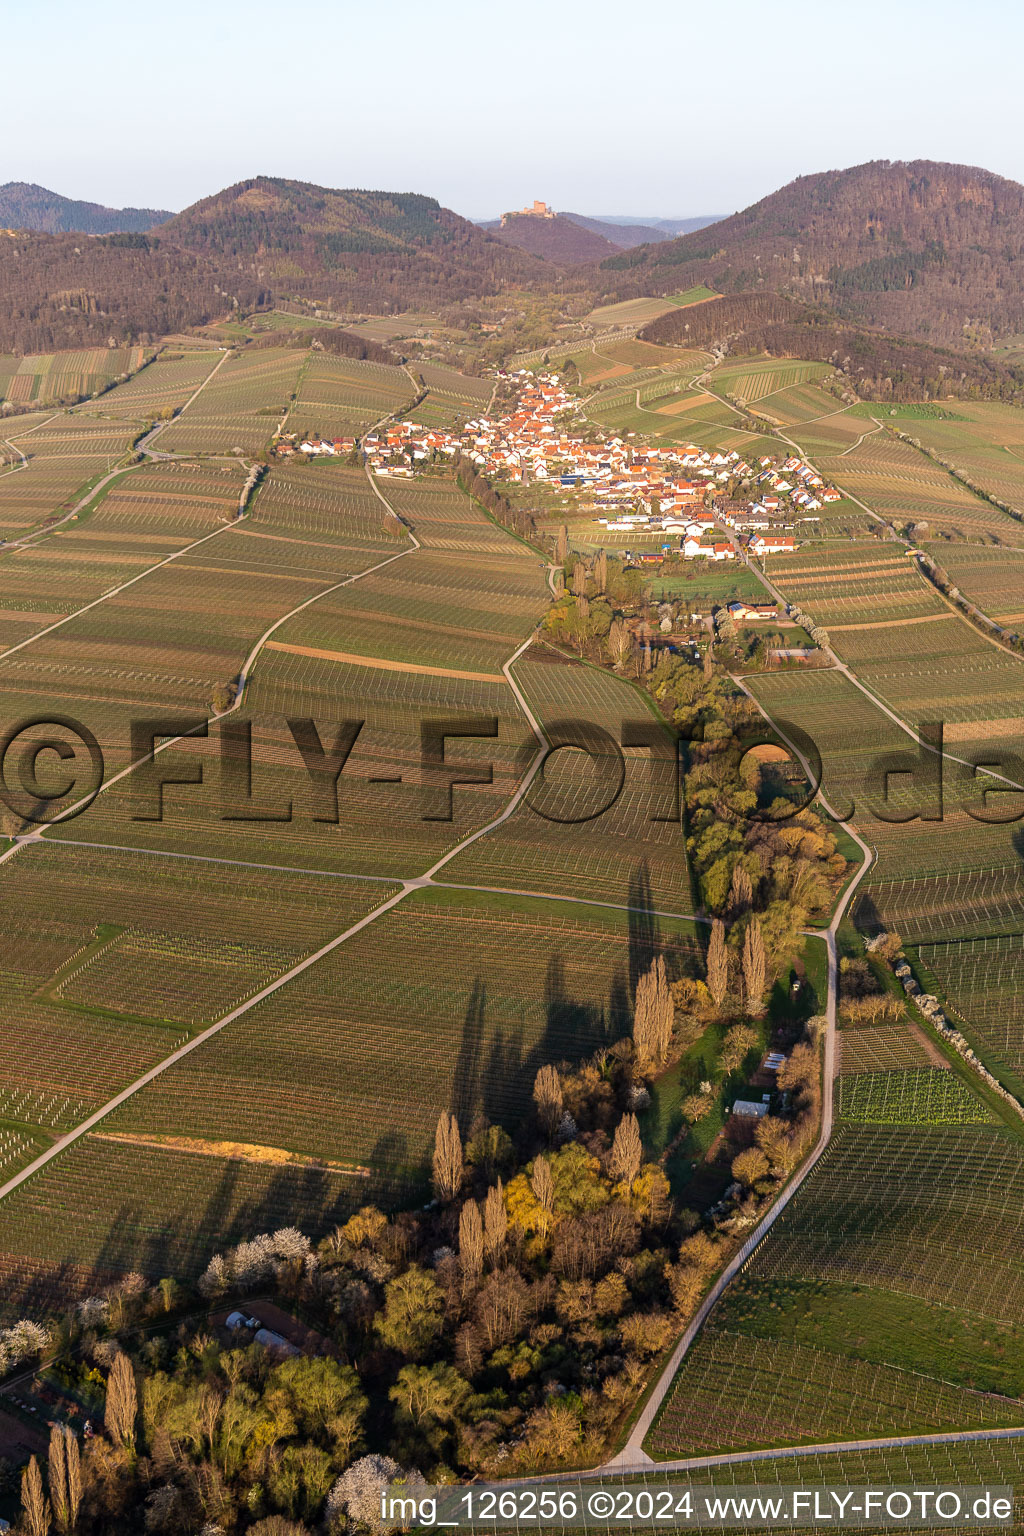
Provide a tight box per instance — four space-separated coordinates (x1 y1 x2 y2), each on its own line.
0 847 387 1129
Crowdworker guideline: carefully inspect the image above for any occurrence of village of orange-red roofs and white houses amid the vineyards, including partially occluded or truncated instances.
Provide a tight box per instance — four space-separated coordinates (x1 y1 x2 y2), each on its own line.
273 370 841 562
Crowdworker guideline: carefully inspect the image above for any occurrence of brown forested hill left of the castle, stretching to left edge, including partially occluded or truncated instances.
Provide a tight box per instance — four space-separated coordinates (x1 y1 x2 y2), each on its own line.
0 177 560 352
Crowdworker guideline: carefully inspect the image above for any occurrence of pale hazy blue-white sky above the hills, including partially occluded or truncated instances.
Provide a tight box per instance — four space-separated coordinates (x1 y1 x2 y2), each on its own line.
10 0 1024 218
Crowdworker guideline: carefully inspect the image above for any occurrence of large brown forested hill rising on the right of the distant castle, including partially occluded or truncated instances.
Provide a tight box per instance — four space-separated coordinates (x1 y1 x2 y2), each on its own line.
600 160 1024 344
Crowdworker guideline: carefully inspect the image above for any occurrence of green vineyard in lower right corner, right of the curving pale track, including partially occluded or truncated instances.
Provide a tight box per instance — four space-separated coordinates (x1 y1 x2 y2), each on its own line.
646 1112 1024 1458
